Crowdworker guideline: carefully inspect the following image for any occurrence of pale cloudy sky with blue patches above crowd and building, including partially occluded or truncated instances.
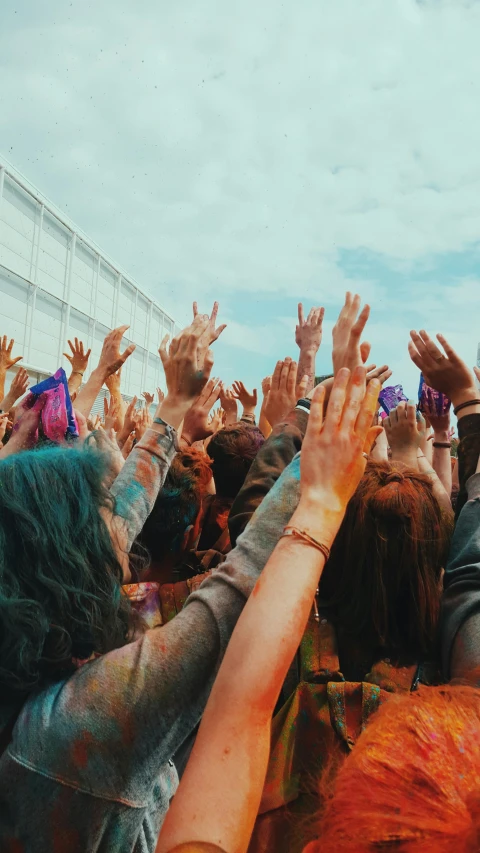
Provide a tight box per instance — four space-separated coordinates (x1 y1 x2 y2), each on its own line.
0 0 480 397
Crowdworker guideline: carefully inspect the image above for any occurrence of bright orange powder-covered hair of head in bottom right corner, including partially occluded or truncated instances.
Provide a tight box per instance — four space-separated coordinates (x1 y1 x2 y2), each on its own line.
304 685 480 853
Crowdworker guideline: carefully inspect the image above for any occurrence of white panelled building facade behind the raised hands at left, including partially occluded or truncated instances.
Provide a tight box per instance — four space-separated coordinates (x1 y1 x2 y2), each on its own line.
0 155 177 410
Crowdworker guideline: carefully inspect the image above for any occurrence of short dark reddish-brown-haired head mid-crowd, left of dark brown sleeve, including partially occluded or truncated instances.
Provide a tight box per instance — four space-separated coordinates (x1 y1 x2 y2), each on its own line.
208 423 265 498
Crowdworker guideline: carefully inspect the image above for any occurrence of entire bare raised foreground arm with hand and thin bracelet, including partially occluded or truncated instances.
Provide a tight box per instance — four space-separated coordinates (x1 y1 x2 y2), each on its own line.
157 367 380 853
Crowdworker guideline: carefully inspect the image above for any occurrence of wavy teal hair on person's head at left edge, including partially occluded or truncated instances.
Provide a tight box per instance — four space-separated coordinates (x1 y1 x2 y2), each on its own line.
0 442 131 698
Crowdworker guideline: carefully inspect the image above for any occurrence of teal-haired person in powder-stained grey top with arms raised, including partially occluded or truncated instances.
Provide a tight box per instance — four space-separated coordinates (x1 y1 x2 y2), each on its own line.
0 315 269 853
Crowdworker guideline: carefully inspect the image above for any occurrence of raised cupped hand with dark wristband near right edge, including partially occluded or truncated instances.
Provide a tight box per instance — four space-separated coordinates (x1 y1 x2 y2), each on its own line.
408 329 479 413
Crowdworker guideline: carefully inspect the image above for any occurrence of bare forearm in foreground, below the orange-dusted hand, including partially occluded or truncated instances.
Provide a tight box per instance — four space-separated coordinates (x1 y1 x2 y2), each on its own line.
157 503 338 853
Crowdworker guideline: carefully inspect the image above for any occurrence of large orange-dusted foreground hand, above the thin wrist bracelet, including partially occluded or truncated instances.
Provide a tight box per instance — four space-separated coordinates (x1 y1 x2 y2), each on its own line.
300 367 382 524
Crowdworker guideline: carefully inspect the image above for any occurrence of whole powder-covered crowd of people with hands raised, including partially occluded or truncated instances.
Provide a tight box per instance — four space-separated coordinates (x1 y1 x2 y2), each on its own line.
0 293 480 853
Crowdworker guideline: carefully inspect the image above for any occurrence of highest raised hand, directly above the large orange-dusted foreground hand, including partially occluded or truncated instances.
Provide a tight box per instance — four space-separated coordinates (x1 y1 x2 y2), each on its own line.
332 292 371 375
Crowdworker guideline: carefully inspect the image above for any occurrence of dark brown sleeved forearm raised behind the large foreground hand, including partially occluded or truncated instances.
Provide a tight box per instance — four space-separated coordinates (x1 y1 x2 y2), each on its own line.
228 409 308 546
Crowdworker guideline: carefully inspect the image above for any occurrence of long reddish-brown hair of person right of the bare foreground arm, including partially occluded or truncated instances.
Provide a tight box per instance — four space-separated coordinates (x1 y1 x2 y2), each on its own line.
320 462 452 660
